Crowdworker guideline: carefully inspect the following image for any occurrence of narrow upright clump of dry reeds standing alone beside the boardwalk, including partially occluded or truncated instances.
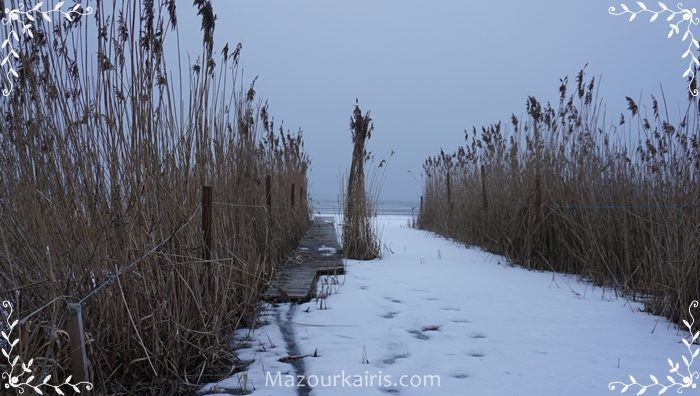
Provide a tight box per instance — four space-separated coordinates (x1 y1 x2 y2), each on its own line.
342 105 381 260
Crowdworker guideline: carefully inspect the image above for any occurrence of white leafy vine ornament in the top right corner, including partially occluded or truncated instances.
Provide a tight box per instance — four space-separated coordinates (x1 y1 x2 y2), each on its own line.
608 1 700 96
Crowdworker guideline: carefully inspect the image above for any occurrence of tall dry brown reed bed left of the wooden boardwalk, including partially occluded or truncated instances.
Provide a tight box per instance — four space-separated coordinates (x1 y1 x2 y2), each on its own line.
0 0 310 394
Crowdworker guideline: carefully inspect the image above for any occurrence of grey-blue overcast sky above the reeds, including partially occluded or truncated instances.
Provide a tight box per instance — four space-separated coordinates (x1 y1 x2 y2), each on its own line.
178 0 692 200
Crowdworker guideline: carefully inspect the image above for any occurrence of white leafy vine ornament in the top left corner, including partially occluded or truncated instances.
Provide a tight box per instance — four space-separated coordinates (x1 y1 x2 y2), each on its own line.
0 1 94 96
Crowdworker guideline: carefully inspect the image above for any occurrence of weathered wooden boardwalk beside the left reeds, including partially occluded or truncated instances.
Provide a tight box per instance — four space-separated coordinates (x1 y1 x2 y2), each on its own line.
263 217 345 303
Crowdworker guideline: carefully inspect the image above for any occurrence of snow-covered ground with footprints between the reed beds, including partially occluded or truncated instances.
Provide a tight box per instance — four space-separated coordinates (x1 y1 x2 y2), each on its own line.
203 216 697 396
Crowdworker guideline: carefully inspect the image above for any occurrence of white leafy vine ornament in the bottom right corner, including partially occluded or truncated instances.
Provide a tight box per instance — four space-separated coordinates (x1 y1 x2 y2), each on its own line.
608 300 700 395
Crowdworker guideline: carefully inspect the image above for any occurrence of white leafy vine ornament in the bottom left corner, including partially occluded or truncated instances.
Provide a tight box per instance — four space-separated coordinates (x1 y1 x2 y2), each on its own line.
0 301 93 395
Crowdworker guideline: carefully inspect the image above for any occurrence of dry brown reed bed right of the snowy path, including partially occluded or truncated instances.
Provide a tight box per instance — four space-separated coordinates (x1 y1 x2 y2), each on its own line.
417 70 700 322
